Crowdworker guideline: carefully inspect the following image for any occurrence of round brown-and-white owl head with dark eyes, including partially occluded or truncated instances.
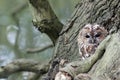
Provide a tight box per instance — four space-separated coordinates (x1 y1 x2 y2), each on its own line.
80 24 108 44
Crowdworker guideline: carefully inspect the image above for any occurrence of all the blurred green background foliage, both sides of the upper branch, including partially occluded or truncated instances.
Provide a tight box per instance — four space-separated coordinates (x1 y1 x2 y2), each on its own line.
0 0 79 80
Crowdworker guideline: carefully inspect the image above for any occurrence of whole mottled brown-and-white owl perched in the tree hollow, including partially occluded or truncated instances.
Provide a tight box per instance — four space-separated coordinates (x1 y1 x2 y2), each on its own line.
78 24 108 59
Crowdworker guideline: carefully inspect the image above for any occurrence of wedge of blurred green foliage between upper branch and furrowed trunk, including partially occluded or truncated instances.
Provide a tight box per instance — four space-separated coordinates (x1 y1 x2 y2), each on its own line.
49 0 80 23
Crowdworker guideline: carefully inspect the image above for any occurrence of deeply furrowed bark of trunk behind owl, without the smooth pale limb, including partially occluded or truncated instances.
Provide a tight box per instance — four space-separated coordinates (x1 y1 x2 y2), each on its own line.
55 0 120 61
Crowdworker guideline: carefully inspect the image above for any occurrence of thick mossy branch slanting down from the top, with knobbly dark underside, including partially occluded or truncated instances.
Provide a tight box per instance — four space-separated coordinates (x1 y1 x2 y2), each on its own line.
29 0 63 44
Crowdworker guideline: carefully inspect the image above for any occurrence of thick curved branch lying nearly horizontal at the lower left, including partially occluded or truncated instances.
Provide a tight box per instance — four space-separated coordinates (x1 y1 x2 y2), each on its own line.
0 59 49 78
